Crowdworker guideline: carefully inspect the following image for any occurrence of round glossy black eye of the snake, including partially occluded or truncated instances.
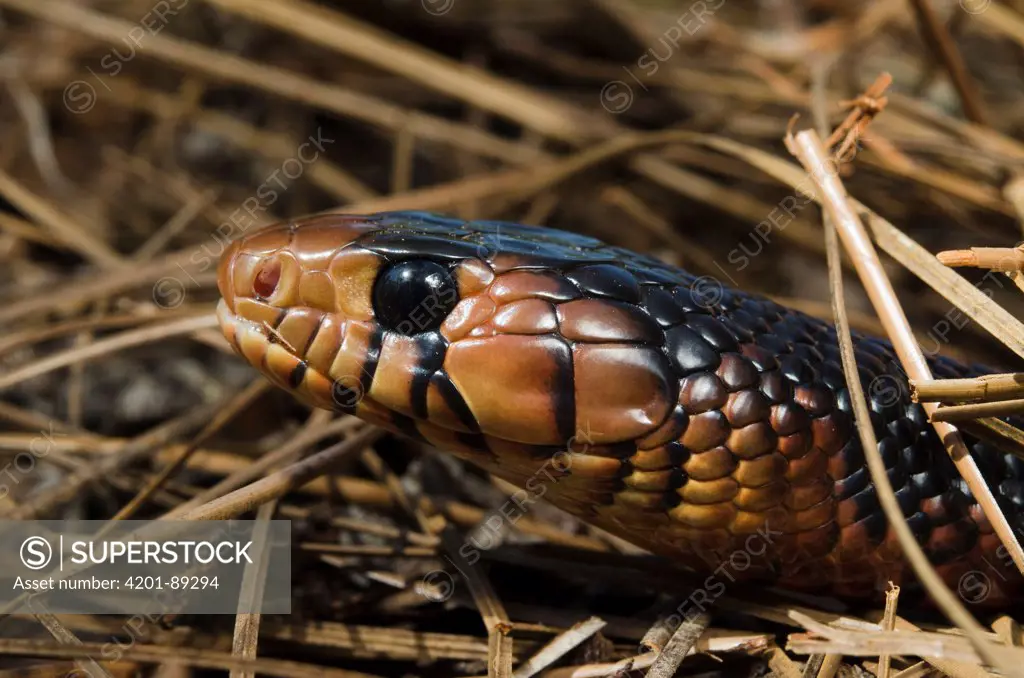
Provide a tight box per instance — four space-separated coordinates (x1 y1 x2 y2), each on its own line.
374 260 459 336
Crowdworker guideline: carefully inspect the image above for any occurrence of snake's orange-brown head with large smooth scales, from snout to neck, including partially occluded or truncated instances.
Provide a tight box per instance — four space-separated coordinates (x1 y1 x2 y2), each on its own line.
218 212 678 451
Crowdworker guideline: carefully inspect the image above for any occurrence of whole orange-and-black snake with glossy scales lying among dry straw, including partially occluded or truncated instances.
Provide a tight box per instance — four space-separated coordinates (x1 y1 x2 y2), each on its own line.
217 211 1024 606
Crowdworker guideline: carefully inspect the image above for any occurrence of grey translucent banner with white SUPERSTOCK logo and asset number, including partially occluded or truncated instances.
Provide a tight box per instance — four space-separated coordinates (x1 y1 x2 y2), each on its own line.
0 520 292 615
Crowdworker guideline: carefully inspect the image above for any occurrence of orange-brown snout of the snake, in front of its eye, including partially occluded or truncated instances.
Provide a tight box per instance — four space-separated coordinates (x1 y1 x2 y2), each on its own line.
217 216 380 412
